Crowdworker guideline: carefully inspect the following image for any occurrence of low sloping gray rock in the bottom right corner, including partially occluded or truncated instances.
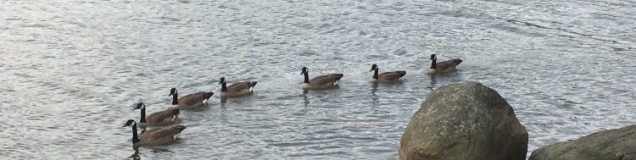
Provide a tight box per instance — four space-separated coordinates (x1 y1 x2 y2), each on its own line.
529 125 636 160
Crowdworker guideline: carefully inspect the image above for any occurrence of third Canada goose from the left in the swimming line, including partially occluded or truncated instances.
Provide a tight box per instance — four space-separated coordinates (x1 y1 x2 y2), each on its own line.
169 88 214 109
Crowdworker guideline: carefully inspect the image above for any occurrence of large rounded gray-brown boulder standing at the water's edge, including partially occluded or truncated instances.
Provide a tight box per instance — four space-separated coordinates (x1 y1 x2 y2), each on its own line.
399 82 528 160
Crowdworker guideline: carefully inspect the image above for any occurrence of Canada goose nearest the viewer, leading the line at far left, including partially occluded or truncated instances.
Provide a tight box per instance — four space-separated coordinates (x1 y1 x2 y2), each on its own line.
122 119 186 148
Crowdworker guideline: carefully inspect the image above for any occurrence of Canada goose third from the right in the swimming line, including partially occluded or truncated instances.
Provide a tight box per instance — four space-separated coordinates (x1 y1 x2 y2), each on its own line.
300 67 344 90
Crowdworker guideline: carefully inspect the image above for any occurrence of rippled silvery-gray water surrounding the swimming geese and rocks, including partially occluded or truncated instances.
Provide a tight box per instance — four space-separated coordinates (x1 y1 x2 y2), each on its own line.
0 0 636 159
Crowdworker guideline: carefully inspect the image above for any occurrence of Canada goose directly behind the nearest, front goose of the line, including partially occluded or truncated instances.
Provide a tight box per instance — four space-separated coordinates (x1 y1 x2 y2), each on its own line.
134 102 179 126
